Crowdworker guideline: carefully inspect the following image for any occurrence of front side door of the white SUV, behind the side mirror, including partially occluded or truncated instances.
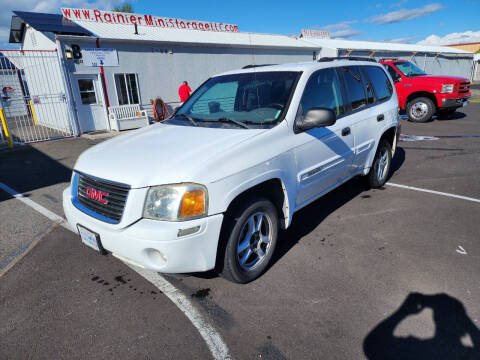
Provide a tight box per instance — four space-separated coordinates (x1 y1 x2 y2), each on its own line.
294 69 354 208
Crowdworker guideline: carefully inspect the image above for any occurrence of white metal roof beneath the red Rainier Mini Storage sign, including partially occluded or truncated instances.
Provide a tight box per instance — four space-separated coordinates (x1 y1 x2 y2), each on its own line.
64 19 318 50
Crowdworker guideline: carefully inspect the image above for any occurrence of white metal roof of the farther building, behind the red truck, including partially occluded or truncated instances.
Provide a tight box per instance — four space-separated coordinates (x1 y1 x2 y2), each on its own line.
302 38 472 55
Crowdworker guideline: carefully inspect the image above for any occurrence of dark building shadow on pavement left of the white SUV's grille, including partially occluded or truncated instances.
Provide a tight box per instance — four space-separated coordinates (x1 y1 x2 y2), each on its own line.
0 145 72 201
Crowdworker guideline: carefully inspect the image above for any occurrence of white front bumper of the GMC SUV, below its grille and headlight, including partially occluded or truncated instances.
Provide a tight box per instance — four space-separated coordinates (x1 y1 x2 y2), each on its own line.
63 187 223 273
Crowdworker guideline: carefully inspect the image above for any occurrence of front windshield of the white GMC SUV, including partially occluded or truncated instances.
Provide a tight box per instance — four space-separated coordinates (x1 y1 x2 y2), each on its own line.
165 71 300 129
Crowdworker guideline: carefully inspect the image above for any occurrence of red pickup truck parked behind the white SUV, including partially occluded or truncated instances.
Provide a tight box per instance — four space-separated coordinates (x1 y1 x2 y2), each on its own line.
380 59 471 122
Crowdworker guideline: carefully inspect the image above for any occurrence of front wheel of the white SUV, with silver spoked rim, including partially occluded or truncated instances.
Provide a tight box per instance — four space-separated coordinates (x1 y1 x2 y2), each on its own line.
220 198 279 284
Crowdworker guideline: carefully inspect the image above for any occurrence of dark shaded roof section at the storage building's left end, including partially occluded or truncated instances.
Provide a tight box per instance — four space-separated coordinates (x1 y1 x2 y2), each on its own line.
9 11 91 43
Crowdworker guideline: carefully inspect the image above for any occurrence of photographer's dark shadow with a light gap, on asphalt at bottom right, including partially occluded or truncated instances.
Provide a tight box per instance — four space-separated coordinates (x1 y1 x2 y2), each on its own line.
363 293 480 360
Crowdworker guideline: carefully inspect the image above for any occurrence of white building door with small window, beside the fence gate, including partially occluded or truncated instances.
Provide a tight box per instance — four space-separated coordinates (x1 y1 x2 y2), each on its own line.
73 75 108 133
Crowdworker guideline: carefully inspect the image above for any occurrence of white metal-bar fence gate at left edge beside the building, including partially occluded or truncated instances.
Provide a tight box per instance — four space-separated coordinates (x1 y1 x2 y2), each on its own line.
0 50 75 144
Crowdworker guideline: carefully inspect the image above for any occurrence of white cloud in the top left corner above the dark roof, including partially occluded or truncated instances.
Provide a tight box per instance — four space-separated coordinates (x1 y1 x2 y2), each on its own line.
0 0 124 47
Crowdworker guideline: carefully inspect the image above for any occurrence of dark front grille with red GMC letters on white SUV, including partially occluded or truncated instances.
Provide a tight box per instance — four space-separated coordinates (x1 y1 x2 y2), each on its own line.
77 174 129 222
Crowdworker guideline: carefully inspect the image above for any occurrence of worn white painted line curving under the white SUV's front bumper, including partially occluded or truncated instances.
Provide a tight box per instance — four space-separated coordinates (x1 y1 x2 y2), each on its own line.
0 183 232 360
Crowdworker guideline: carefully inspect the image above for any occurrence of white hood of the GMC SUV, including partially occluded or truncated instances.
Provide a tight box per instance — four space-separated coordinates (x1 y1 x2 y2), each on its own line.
75 124 266 188
